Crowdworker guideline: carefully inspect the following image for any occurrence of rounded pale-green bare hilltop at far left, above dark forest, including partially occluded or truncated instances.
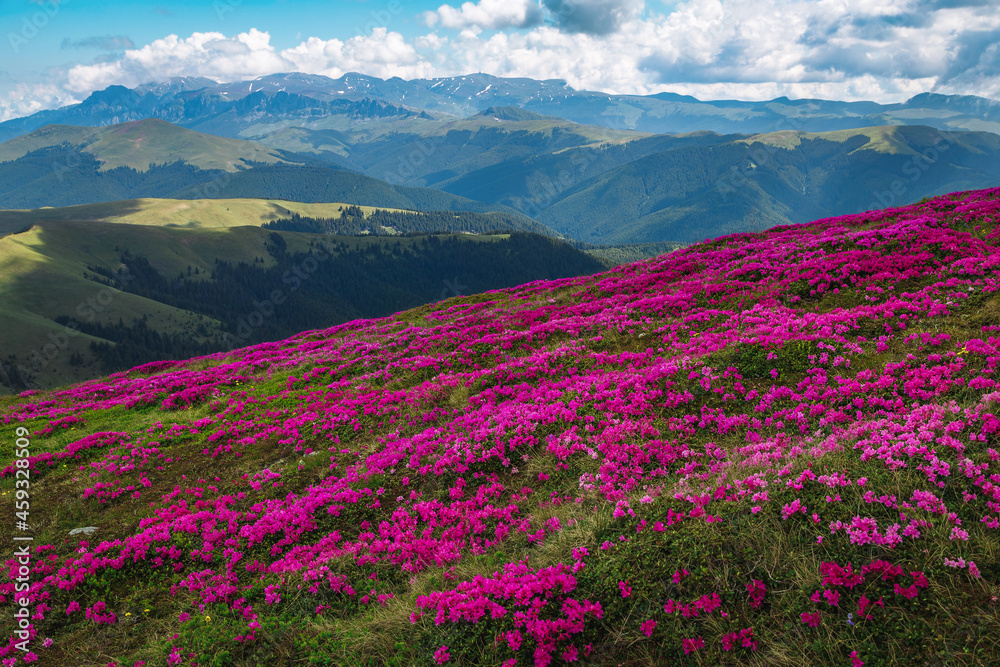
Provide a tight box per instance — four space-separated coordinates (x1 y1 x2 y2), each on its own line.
0 118 292 172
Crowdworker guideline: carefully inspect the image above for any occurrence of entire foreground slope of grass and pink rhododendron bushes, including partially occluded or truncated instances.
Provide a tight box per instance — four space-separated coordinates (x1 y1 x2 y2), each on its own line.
0 189 1000 667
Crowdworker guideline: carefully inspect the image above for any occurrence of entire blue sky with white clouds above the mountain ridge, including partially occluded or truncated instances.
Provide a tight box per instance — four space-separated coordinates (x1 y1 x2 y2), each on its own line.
0 0 1000 121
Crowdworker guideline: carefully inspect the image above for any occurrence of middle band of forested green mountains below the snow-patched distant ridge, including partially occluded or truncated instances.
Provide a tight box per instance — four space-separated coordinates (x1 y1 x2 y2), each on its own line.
0 115 1000 244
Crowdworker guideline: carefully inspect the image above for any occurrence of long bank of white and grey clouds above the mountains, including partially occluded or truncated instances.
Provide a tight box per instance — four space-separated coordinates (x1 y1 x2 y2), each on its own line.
0 0 1000 124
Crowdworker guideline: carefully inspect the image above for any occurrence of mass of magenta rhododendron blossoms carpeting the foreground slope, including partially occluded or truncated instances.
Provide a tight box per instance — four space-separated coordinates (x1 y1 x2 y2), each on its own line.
0 189 1000 665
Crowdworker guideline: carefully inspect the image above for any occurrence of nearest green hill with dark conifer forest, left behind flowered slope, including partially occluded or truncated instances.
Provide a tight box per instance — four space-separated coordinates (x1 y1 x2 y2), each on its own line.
0 200 606 390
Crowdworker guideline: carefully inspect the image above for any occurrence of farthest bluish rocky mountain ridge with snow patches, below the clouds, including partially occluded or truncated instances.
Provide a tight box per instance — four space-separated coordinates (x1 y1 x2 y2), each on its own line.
0 73 1000 141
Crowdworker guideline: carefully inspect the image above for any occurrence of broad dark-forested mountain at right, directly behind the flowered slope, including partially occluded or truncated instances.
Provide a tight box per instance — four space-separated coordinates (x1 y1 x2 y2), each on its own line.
536 126 1000 243
